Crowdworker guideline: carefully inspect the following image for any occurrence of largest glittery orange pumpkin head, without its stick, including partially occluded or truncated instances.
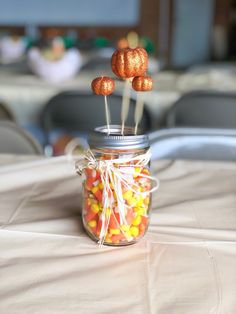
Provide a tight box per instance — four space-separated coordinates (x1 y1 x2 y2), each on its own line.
111 47 148 78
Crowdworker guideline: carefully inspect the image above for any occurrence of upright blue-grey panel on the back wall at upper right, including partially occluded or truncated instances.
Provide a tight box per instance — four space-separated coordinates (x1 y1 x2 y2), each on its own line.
171 0 214 67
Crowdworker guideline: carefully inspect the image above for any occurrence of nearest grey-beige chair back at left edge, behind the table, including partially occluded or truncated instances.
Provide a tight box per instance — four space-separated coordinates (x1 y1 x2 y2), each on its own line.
0 121 43 155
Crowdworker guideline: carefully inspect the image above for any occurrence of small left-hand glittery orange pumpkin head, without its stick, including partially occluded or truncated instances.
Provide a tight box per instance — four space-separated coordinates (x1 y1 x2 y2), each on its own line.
91 76 115 96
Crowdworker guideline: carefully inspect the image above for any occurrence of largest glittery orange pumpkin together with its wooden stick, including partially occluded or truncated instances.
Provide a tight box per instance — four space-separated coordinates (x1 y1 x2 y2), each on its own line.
111 47 148 134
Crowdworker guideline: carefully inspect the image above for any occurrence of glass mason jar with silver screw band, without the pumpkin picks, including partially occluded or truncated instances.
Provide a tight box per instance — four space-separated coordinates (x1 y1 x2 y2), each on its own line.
82 126 151 246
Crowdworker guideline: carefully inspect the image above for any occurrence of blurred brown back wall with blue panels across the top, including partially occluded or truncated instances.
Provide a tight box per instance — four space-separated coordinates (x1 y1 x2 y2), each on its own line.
0 0 236 68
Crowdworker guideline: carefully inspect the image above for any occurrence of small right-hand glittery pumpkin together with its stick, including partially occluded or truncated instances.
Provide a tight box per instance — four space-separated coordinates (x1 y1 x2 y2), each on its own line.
132 76 153 134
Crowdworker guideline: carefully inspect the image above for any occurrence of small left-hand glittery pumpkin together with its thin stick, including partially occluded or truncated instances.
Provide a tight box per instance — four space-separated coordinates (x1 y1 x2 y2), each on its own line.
91 76 115 134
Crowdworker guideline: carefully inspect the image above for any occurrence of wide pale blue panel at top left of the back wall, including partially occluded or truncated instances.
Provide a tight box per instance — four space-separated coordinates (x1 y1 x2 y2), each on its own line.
0 0 139 26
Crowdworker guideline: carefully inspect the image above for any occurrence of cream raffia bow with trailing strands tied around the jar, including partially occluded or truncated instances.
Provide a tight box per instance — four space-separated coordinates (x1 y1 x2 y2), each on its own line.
75 149 159 245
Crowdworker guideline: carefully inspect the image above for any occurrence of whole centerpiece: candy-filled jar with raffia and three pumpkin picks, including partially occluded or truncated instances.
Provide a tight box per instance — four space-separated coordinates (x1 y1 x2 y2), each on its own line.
78 48 157 246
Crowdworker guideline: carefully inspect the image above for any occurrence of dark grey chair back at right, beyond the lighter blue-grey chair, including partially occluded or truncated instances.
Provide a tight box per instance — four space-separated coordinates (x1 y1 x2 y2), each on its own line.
167 91 236 129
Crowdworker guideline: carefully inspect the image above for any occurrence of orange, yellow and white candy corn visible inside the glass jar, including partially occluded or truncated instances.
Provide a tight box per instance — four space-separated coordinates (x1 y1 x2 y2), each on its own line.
83 155 151 244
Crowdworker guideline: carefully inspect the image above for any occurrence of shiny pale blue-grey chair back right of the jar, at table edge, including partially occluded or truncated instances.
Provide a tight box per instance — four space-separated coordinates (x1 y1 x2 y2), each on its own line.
149 128 236 161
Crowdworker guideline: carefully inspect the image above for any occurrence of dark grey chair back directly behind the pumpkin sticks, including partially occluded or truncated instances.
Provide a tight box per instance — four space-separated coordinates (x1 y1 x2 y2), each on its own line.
41 91 151 152
